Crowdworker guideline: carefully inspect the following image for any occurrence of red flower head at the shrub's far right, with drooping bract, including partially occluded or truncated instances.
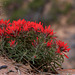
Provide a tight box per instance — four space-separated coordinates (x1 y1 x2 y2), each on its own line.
56 40 70 58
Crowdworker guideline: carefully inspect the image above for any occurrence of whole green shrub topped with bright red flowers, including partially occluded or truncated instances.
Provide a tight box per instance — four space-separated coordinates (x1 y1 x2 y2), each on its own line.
0 19 70 71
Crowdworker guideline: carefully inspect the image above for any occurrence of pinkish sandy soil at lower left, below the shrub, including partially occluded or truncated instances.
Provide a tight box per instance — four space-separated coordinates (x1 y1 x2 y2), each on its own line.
0 56 33 75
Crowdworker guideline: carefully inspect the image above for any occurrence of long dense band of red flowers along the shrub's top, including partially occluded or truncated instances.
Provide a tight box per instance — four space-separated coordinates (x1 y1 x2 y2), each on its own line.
0 19 54 37
